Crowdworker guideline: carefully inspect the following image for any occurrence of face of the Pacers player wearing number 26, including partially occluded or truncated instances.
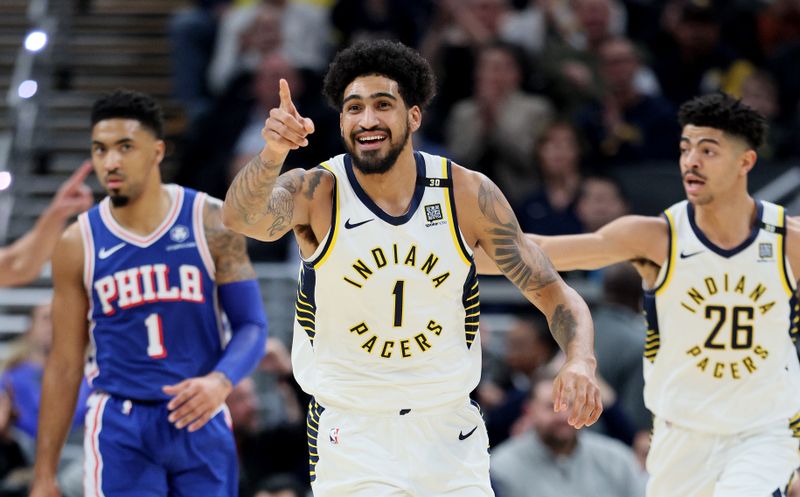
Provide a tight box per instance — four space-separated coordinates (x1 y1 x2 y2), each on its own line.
680 124 756 205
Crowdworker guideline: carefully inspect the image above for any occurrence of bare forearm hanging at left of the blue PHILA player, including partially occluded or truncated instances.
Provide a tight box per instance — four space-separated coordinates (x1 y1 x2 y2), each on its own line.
34 356 83 480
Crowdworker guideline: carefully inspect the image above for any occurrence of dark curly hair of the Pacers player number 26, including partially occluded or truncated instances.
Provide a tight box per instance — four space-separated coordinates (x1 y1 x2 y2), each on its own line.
678 92 767 150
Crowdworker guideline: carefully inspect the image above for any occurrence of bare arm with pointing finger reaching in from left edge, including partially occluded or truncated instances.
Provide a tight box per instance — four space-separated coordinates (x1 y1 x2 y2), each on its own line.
0 161 93 287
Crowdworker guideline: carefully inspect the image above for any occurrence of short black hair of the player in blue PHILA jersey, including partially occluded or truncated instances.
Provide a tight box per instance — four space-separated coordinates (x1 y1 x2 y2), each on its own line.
91 89 164 140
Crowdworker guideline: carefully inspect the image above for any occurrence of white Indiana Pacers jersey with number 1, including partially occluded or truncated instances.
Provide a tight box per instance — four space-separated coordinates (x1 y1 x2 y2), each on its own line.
292 152 481 412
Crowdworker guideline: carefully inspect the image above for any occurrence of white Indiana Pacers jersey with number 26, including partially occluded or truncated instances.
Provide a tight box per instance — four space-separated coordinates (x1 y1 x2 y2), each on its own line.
644 201 800 434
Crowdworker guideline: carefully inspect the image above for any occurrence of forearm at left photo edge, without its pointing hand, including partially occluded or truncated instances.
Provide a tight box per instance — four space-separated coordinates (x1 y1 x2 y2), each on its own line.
0 207 66 286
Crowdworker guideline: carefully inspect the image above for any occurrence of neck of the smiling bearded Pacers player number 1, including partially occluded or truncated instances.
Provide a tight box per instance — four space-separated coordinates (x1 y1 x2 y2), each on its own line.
354 146 417 216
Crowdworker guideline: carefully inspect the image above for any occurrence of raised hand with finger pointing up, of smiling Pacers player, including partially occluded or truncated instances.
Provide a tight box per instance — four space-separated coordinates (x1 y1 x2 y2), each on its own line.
261 79 314 155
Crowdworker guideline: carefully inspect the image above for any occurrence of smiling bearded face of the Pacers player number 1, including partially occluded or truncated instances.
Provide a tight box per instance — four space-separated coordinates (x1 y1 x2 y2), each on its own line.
339 75 421 174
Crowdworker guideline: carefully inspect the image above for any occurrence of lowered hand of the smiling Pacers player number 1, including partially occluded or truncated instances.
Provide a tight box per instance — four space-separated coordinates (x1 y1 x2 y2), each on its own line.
553 359 603 429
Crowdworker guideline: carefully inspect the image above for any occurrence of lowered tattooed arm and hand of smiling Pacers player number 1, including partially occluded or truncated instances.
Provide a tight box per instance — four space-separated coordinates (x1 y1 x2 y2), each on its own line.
453 166 602 428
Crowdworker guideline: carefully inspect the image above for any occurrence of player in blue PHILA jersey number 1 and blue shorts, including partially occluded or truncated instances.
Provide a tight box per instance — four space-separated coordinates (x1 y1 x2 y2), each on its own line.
31 90 266 497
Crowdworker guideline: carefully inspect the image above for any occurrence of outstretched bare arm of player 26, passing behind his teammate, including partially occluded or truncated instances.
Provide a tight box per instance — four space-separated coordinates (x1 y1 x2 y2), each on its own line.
475 216 669 274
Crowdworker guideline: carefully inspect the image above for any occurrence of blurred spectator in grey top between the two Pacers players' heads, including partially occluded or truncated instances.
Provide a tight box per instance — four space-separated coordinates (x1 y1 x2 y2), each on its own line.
446 41 554 204
